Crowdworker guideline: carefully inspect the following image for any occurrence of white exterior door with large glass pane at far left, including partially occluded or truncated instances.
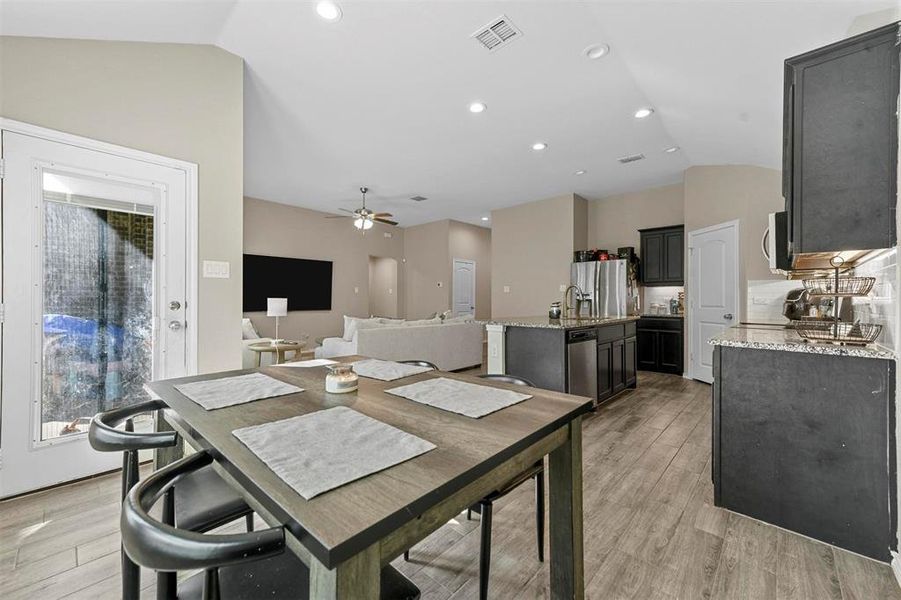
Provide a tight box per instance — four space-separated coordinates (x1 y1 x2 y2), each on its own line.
0 129 193 497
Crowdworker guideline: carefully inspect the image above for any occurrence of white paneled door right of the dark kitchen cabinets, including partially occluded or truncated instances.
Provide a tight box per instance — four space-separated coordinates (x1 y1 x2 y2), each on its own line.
688 221 739 383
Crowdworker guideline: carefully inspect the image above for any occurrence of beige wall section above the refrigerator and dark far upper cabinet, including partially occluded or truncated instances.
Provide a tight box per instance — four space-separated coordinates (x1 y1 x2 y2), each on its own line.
587 182 685 248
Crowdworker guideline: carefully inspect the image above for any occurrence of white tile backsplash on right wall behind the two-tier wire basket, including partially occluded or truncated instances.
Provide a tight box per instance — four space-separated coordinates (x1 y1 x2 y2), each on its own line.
853 248 898 351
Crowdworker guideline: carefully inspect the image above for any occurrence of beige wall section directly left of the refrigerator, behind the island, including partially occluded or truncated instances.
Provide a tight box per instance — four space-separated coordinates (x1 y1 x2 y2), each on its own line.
491 194 587 318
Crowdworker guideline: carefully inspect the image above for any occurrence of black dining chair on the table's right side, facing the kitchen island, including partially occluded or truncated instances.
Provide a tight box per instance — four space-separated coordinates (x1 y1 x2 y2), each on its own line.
404 373 544 600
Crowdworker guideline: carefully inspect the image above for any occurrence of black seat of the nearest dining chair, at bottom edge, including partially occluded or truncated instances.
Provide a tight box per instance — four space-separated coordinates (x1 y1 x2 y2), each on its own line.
178 550 419 600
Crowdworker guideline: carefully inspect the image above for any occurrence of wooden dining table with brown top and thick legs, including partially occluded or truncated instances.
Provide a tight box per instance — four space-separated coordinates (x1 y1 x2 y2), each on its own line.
148 356 592 600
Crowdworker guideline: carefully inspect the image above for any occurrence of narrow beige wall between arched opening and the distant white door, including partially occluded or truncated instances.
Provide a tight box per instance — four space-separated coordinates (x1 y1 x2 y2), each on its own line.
404 219 450 319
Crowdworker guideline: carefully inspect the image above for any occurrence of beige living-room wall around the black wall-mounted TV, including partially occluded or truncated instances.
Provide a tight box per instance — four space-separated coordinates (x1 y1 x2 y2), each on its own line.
239 198 404 341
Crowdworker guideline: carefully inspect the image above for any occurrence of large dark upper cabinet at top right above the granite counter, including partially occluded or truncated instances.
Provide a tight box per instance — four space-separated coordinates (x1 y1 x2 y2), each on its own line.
782 23 899 254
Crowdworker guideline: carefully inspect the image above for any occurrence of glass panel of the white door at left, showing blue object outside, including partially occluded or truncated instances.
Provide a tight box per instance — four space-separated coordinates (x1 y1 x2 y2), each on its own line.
39 172 154 441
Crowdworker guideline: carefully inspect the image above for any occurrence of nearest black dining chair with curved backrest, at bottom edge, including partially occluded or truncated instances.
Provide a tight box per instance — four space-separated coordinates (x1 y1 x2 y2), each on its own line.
120 451 420 600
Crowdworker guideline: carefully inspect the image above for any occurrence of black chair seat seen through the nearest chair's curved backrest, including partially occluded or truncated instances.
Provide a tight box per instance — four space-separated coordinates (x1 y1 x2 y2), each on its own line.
175 465 252 533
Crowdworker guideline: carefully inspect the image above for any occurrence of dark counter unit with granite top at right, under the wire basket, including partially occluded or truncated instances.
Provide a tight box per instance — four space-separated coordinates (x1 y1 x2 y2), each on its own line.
709 326 897 561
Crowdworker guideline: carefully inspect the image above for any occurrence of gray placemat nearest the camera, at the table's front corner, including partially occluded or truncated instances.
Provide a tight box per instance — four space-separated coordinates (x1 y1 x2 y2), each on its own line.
233 406 436 500
